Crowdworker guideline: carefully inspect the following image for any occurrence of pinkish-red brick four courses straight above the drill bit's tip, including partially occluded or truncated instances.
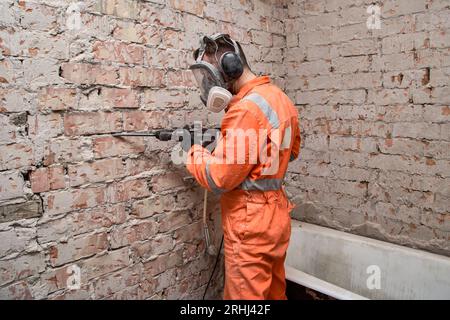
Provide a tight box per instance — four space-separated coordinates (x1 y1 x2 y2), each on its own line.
93 41 144 64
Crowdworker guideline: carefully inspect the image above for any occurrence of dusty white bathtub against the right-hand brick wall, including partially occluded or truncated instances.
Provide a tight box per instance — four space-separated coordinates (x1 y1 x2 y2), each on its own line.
286 220 450 300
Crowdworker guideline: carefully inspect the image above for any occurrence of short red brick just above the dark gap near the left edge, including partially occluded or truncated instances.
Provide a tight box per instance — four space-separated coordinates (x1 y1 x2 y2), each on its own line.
31 166 66 193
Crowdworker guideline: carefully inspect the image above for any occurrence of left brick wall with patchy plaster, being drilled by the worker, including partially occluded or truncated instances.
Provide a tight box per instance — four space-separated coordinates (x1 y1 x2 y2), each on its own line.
0 0 286 299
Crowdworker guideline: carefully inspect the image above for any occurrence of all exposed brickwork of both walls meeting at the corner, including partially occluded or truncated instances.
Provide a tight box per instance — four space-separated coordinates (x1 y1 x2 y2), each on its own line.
0 0 450 299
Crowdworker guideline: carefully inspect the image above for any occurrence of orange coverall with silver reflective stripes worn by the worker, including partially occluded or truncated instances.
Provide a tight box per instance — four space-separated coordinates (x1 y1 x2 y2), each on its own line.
187 76 300 300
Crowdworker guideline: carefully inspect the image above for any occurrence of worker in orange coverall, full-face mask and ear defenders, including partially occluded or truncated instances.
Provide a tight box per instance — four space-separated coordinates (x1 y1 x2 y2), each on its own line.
187 34 300 300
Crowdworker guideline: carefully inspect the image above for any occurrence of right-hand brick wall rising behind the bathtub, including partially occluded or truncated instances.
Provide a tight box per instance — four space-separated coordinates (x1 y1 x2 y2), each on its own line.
284 0 450 256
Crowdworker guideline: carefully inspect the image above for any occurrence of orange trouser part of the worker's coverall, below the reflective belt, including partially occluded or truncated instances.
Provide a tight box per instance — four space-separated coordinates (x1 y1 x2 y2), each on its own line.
221 192 291 300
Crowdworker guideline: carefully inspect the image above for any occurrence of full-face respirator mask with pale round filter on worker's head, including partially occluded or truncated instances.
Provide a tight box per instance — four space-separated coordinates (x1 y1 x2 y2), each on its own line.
189 34 244 112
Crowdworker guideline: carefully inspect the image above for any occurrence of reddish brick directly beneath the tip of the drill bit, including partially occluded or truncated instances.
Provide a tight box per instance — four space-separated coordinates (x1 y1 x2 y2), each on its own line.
93 137 145 158
